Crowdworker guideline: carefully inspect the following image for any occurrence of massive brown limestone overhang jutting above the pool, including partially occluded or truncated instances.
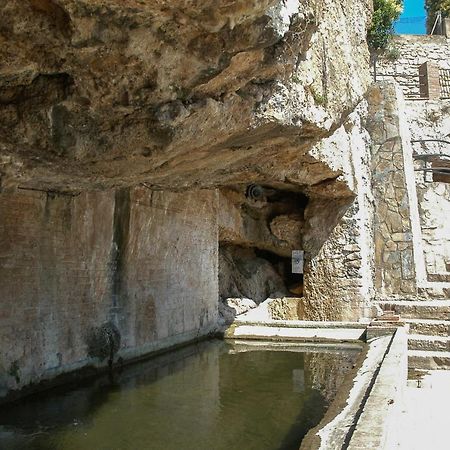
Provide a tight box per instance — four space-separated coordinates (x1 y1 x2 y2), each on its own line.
0 0 371 195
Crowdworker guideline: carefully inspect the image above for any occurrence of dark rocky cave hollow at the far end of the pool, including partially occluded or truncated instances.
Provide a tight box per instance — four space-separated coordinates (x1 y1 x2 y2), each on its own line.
219 184 309 322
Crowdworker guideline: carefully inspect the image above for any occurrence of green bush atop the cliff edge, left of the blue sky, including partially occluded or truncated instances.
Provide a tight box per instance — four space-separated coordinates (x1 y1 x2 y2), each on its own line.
367 0 402 51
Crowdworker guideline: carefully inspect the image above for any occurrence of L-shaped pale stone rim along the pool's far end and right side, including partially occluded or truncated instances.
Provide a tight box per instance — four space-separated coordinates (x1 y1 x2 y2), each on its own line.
224 320 408 450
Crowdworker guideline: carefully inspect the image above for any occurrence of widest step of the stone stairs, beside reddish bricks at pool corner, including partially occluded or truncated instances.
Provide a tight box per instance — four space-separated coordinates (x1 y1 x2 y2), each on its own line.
377 300 450 320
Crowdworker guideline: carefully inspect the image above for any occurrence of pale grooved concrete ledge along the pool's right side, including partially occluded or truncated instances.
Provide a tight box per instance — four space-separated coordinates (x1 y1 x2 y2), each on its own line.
300 327 408 450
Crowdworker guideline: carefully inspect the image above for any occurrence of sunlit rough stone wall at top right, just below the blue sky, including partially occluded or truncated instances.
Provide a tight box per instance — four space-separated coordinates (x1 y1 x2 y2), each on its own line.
377 35 450 98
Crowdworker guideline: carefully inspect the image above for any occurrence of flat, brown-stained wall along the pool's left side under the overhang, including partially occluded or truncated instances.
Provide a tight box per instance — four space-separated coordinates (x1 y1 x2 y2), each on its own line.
0 188 218 397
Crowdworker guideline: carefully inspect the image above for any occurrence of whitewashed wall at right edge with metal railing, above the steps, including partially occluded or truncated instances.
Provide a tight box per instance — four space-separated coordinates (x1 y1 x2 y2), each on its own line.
405 100 450 298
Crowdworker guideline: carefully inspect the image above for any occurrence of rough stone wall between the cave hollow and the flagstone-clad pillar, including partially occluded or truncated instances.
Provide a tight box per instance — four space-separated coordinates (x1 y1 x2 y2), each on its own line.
305 102 373 320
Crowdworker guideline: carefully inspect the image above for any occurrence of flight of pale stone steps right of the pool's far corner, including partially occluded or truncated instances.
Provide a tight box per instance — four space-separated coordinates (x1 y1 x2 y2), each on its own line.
378 300 450 370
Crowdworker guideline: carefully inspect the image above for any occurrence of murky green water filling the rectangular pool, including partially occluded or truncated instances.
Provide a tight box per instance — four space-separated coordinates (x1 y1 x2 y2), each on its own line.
0 340 360 450
